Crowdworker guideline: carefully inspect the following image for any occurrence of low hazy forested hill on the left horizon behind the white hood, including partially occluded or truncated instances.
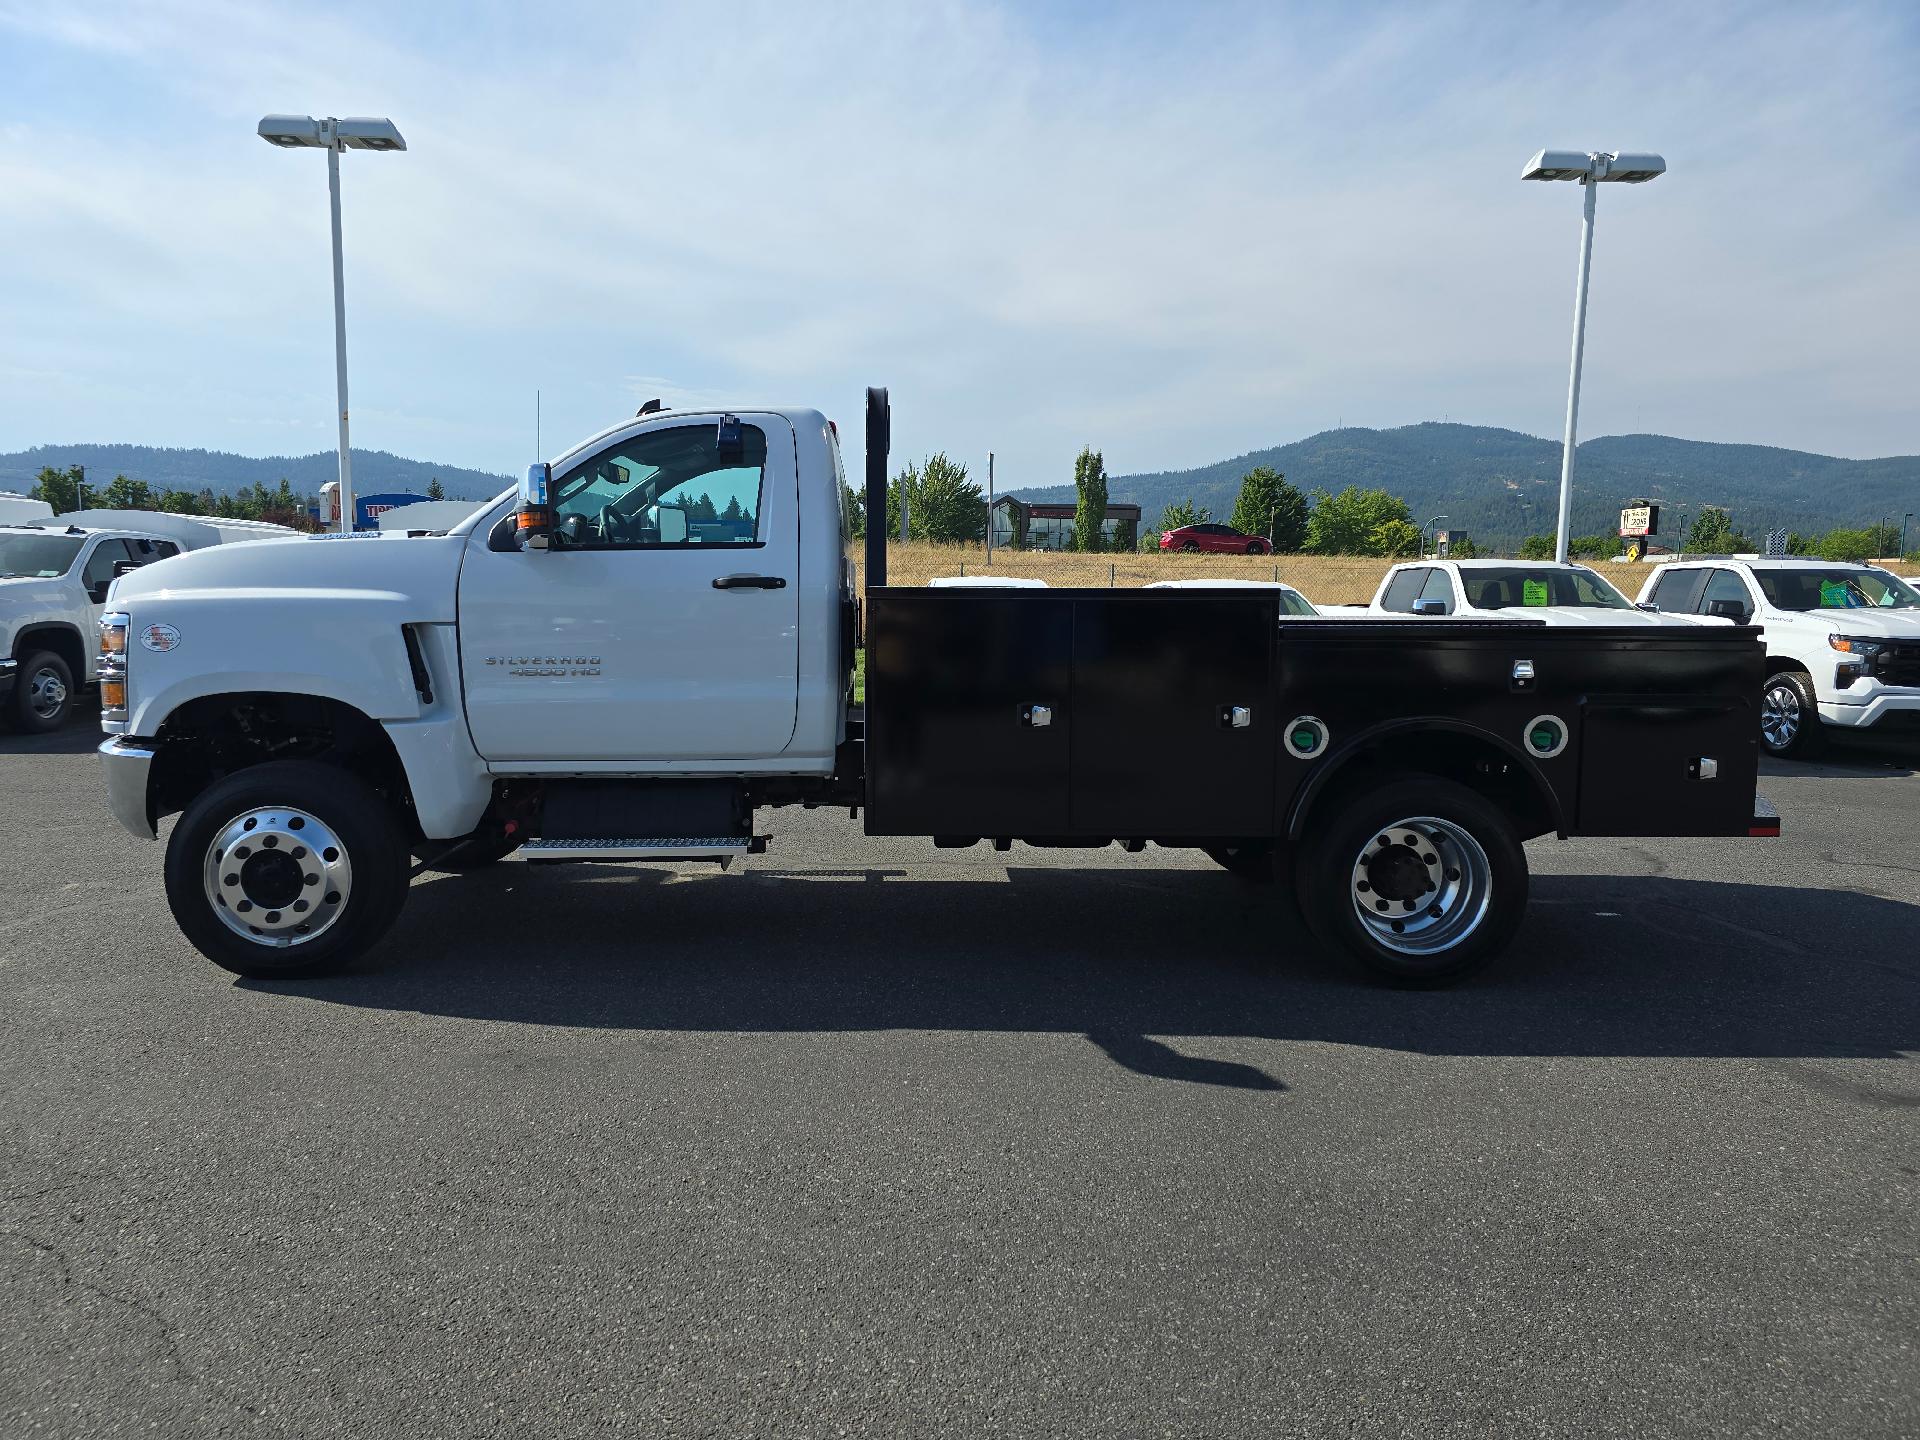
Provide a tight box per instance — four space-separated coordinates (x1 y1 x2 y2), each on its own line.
0 445 513 499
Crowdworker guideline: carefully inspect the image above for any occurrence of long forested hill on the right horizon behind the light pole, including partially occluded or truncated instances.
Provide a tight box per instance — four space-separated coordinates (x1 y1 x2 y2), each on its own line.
1014 420 1920 540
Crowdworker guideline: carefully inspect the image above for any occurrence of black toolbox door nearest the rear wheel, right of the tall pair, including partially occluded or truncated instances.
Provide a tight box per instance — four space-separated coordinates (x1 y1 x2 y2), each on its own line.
1071 589 1279 839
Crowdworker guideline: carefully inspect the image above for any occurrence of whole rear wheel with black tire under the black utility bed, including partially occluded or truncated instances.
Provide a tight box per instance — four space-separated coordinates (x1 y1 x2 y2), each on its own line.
1296 776 1526 985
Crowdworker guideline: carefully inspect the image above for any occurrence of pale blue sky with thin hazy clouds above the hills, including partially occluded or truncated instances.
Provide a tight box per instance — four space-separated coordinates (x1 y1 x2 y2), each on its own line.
0 0 1920 488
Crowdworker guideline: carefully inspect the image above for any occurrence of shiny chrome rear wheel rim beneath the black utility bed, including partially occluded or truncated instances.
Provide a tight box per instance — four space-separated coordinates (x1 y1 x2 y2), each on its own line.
1348 816 1494 956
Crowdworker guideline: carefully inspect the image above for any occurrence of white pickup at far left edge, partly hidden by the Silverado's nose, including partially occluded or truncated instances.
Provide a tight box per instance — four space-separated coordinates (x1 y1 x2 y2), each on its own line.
0 505 221 733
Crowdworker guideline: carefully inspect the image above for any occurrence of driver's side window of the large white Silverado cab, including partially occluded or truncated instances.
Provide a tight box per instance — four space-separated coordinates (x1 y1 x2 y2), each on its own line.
553 422 766 549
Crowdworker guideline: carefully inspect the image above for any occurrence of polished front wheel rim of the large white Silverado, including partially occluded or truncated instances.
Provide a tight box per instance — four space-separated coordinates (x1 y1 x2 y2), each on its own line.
200 806 353 948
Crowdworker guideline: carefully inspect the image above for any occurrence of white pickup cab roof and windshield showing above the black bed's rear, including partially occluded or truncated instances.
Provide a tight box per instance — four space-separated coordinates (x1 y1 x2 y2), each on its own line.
1367 561 1672 626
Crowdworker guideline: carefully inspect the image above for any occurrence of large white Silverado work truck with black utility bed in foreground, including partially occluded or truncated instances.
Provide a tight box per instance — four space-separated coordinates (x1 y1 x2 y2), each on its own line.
86 392 1778 985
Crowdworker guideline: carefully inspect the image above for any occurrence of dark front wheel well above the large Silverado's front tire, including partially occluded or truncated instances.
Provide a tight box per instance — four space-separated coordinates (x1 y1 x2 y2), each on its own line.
148 691 419 831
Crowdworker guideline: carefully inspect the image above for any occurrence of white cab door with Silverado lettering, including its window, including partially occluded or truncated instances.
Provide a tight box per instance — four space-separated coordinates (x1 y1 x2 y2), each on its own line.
459 415 801 770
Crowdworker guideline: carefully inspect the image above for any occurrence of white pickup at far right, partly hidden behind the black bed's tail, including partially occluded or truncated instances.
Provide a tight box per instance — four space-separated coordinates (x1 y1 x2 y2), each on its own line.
1640 555 1920 756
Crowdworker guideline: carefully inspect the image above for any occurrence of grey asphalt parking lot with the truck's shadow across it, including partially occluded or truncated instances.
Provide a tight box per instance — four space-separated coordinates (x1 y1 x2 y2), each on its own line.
0 724 1920 1436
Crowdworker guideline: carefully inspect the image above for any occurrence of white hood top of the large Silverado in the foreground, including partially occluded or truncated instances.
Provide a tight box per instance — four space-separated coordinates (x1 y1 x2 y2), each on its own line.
108 536 467 622
